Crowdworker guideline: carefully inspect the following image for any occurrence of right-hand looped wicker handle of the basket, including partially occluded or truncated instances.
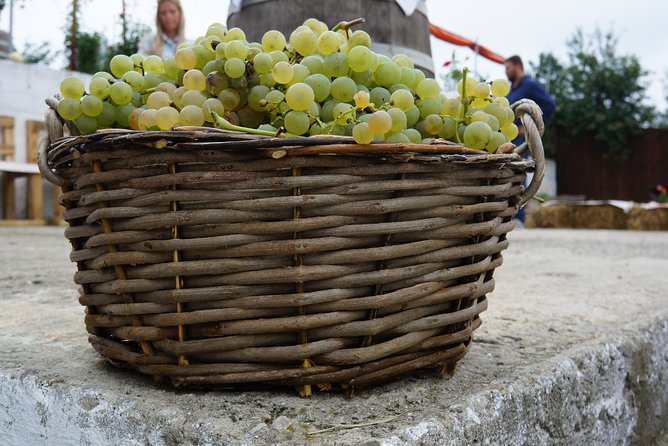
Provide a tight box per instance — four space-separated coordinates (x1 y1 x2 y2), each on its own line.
510 99 545 207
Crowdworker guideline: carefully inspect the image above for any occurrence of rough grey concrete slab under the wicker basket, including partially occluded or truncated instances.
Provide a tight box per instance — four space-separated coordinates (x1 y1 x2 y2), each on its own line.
0 228 668 446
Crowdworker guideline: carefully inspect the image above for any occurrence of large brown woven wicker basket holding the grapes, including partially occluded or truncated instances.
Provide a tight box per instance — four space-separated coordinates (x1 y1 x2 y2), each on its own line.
39 101 544 394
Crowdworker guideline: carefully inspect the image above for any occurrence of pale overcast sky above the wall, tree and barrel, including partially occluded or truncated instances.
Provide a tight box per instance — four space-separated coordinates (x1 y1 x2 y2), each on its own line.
0 0 668 110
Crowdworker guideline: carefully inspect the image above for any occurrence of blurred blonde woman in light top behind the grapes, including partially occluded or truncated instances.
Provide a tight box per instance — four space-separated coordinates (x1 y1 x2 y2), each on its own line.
139 0 185 59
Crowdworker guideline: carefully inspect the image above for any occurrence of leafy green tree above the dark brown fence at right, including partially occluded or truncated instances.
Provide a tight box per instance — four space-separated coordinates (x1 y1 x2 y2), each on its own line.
530 30 654 161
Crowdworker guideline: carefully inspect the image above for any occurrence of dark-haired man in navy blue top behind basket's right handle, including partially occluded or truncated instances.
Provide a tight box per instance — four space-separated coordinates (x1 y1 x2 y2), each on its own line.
506 56 557 145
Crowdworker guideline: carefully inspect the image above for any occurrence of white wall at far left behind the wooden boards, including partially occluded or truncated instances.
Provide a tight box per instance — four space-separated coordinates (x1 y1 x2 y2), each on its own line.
0 60 91 218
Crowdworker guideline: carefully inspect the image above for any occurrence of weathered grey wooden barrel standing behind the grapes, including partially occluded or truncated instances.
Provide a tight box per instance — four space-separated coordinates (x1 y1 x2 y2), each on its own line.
227 0 434 76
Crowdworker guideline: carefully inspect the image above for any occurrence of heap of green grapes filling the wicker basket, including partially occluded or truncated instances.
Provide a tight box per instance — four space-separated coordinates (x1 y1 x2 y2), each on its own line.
58 19 517 151
